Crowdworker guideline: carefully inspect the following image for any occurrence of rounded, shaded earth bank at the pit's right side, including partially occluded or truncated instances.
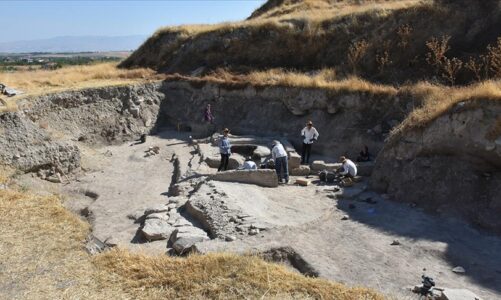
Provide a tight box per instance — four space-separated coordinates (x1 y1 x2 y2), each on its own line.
371 101 501 233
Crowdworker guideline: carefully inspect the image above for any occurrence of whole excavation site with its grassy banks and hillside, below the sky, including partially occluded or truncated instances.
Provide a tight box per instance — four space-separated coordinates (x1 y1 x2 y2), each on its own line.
0 0 501 300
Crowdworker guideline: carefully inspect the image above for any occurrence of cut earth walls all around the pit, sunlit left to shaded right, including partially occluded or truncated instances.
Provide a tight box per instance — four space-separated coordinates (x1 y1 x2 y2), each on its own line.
0 81 501 232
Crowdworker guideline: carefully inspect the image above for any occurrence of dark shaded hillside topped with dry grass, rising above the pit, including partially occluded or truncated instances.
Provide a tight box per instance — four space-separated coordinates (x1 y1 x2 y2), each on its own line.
120 0 501 85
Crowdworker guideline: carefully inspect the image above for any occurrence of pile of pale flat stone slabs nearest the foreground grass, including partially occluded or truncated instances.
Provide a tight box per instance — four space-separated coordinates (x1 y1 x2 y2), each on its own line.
141 198 209 255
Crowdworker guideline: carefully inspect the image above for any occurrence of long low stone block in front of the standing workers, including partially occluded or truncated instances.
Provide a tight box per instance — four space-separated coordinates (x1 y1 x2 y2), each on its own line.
209 169 278 187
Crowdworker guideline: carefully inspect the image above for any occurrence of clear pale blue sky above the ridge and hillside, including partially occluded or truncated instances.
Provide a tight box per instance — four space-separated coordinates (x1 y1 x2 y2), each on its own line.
0 0 265 42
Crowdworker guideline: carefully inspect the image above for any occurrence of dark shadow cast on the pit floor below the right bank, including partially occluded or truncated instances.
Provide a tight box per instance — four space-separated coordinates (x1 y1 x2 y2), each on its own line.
337 192 501 292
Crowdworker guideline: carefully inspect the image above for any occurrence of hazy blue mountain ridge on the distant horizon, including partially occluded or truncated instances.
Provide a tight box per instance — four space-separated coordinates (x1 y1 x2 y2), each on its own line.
0 35 147 53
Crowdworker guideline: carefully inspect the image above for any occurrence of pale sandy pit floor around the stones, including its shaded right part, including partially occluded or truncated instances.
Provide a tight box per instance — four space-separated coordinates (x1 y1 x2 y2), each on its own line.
17 133 501 299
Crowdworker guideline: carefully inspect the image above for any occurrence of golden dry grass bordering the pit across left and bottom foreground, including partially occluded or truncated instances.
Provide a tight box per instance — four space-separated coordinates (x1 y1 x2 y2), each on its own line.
0 168 384 300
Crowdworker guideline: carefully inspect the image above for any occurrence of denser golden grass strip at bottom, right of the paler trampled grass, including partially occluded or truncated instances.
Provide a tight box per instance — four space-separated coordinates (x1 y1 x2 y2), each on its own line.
96 250 383 300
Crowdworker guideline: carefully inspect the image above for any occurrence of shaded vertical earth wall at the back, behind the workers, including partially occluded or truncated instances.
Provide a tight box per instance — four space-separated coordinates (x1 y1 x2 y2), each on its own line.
157 81 408 159
